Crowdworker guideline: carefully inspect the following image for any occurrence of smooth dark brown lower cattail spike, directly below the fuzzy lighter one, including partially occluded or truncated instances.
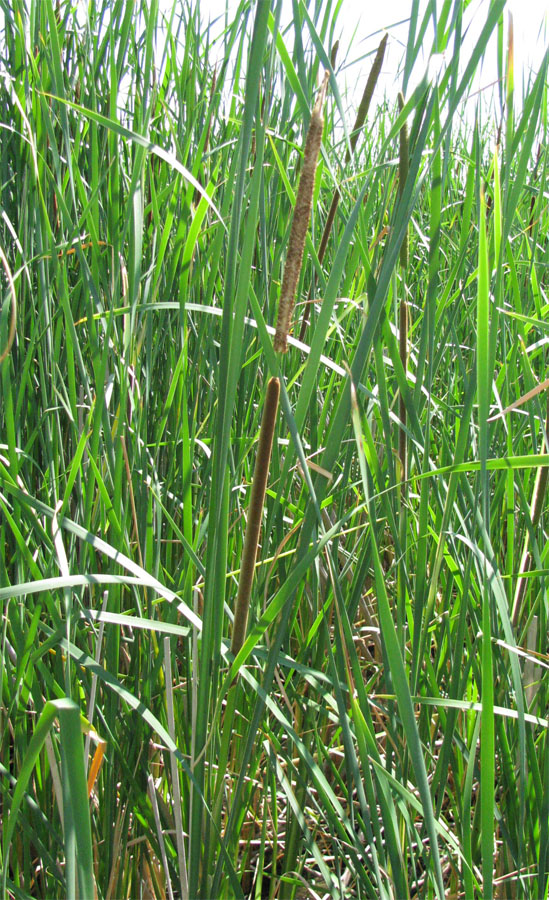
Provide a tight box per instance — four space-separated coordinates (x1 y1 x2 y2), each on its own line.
231 378 280 656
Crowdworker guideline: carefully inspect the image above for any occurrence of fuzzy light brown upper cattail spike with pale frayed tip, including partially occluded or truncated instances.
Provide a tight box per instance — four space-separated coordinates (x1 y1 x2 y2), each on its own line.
274 72 329 353
